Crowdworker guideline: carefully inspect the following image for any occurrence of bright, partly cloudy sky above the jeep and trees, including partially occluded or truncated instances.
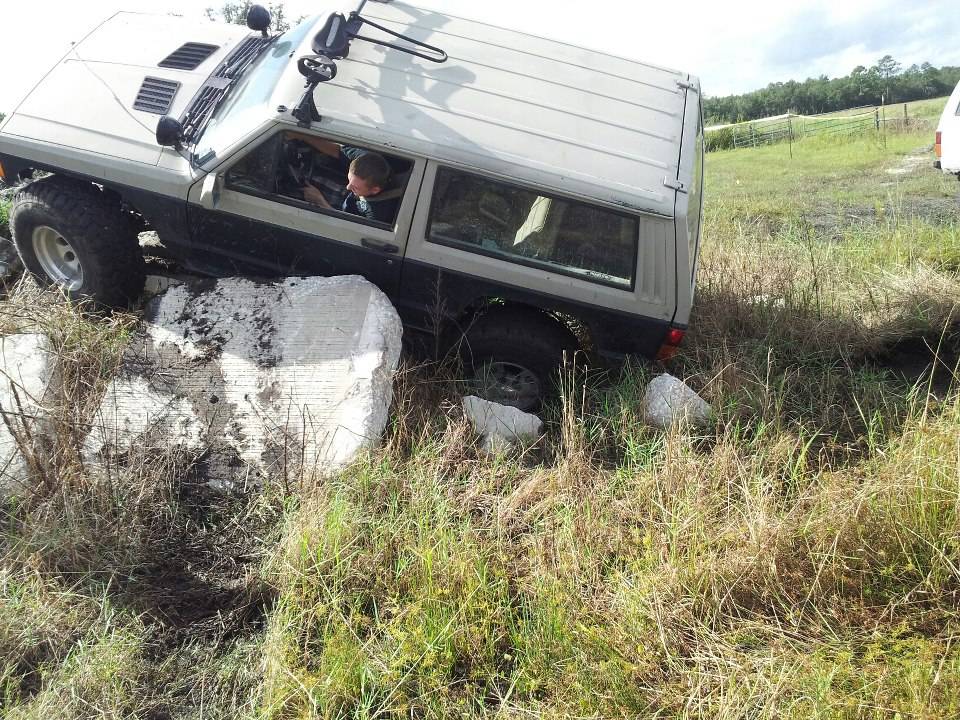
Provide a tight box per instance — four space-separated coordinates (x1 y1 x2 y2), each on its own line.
0 0 960 112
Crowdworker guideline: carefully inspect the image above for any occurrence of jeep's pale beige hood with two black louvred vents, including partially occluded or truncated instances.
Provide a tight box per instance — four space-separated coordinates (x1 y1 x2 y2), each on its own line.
3 12 250 165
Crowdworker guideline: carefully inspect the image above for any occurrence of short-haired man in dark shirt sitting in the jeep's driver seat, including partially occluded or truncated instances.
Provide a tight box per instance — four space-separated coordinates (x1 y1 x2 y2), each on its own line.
294 135 399 224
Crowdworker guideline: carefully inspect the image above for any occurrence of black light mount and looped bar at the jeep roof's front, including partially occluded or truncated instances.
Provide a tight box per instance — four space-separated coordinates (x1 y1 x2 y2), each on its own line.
293 0 447 127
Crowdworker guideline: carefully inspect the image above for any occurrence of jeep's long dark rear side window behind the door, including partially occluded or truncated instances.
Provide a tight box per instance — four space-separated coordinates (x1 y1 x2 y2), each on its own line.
427 168 639 289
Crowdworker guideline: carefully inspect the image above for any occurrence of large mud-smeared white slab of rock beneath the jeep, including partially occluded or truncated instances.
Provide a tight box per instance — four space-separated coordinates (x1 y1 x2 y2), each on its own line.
84 276 402 489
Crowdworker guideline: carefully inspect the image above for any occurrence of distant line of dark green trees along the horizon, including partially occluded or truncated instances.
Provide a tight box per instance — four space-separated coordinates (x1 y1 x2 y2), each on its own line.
703 55 960 125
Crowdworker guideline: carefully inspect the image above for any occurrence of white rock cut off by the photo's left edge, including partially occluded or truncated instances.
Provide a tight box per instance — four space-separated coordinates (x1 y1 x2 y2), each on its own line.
0 333 54 496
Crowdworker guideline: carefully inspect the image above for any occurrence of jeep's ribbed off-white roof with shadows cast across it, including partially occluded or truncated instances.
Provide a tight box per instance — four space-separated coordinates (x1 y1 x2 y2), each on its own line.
274 2 699 216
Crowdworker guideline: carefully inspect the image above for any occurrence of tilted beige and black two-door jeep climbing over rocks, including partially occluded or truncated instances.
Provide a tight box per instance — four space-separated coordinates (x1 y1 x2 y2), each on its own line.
0 0 703 407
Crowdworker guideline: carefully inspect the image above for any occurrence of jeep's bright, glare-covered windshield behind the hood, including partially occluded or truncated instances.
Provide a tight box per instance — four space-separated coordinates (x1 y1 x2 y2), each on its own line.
195 18 314 158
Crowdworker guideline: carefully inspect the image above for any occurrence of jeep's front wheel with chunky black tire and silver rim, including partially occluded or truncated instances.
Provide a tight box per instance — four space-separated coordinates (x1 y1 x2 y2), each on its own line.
10 176 145 307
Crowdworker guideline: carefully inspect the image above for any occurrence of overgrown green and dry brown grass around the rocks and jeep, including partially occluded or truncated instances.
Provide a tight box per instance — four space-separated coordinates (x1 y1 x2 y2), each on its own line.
0 126 960 720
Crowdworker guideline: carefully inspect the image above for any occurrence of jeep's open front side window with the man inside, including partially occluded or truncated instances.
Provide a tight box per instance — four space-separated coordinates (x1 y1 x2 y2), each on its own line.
225 131 413 226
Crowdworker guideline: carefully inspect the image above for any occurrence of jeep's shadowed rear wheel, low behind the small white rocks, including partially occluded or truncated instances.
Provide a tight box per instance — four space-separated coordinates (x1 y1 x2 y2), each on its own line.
462 308 579 412
